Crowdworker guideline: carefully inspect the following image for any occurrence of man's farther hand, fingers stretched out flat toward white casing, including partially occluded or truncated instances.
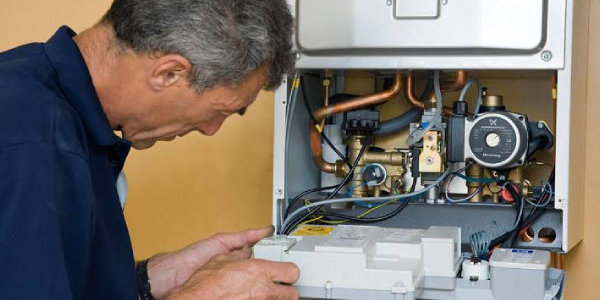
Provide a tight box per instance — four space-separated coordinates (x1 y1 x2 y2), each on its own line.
148 226 275 299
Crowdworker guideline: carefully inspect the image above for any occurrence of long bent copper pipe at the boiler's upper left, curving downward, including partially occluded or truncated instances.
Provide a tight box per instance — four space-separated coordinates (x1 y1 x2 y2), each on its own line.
310 73 402 173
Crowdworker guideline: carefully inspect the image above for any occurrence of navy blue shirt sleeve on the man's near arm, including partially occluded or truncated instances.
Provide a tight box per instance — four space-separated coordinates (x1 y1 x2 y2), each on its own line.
0 143 94 300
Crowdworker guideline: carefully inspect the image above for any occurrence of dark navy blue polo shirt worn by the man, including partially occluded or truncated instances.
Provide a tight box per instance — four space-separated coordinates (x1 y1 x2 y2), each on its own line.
0 27 137 300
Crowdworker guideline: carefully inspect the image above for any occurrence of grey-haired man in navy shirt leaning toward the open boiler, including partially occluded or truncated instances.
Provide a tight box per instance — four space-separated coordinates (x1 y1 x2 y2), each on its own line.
0 0 299 300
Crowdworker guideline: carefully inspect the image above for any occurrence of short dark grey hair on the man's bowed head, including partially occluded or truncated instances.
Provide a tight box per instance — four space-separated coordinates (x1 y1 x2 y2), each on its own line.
101 0 294 92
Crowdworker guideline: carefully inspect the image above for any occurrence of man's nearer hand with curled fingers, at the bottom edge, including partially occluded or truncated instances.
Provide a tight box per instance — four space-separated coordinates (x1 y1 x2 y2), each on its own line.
168 248 300 300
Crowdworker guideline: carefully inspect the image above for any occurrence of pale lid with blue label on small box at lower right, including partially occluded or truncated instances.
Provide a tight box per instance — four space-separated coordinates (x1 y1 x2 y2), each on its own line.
490 249 550 270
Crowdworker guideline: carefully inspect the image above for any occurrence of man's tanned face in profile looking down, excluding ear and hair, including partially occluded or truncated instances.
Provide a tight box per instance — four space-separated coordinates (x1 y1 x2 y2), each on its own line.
122 68 267 149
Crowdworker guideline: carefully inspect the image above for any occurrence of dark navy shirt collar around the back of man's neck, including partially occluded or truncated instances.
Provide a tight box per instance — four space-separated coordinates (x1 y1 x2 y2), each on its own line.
44 26 122 146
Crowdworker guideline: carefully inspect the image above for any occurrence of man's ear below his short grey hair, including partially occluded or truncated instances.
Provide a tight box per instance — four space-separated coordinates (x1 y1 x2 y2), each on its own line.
148 54 192 91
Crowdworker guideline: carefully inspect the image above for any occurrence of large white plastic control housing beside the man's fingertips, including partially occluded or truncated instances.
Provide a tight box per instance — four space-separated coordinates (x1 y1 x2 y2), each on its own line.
254 226 461 293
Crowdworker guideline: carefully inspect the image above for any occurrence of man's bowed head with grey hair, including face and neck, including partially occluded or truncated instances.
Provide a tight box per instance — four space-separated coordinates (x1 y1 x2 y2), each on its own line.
76 0 293 149
